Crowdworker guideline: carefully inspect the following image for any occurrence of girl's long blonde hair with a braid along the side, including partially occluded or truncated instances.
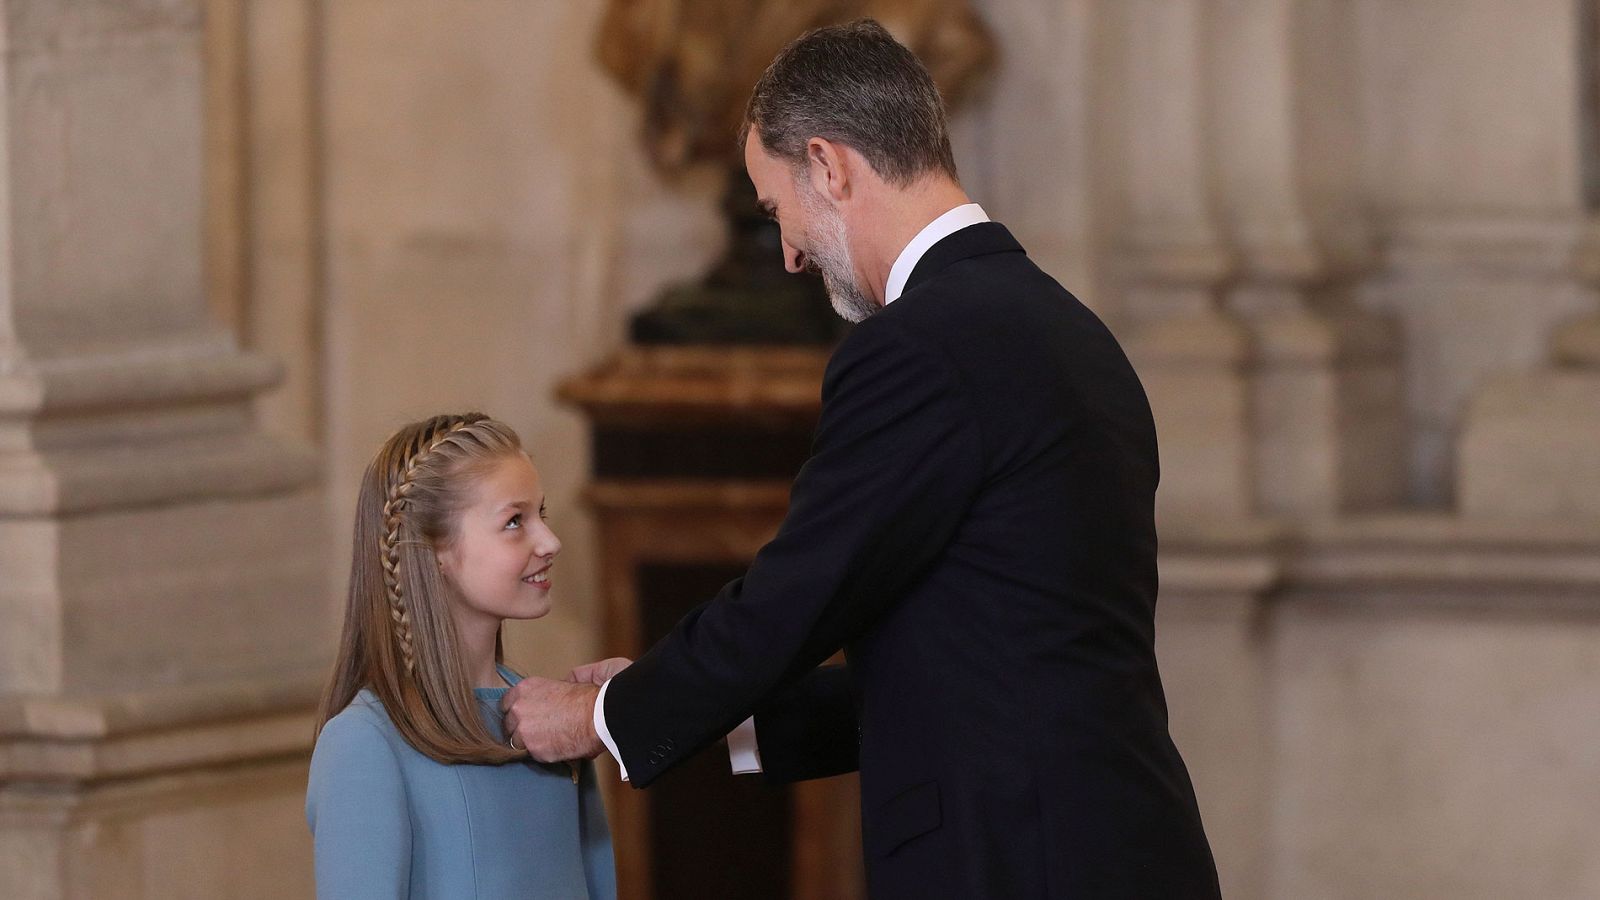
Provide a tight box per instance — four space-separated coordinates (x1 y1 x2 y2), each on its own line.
317 413 523 764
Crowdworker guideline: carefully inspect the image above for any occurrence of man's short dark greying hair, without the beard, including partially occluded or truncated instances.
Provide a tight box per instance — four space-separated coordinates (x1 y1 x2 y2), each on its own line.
739 19 955 187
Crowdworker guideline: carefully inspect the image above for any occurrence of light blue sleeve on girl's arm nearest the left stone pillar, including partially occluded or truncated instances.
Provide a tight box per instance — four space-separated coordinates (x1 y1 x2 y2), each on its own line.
306 713 411 900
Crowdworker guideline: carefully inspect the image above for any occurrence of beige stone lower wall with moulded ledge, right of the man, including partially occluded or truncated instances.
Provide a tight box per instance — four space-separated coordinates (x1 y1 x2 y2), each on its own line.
1157 516 1600 898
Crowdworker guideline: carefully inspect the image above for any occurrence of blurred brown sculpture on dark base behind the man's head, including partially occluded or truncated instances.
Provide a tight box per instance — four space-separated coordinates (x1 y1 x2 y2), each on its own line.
597 0 994 344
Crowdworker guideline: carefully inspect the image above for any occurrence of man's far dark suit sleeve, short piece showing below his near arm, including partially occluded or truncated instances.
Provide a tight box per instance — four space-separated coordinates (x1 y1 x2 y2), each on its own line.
755 666 861 785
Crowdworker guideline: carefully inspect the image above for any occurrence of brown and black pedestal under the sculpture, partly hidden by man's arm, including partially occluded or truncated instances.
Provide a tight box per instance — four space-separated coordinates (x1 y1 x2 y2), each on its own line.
562 348 864 900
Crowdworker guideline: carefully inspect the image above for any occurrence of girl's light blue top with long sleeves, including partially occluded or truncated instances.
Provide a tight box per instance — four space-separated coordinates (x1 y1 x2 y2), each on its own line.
306 668 616 900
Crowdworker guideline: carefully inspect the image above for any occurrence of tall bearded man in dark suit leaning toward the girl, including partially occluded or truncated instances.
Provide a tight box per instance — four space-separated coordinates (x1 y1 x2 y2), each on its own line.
506 21 1219 900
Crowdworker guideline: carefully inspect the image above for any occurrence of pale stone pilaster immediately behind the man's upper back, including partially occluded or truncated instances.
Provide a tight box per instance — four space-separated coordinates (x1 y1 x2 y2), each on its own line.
1109 0 1253 519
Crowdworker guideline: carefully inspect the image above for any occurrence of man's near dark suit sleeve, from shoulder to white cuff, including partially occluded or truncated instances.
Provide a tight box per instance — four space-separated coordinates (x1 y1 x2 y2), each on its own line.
603 314 982 788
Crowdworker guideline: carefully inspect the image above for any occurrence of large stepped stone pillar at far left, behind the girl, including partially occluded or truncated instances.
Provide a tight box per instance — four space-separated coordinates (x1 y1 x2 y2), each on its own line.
0 0 324 900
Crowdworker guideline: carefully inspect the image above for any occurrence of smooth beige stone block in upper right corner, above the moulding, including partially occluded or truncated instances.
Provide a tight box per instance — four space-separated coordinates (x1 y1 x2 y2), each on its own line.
1355 0 1581 219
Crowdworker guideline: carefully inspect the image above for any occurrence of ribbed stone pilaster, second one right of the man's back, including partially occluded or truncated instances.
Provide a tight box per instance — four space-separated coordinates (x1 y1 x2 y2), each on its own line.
1208 0 1405 516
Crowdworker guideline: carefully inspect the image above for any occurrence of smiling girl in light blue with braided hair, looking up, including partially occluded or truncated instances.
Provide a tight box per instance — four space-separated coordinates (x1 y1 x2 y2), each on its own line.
306 413 616 900
